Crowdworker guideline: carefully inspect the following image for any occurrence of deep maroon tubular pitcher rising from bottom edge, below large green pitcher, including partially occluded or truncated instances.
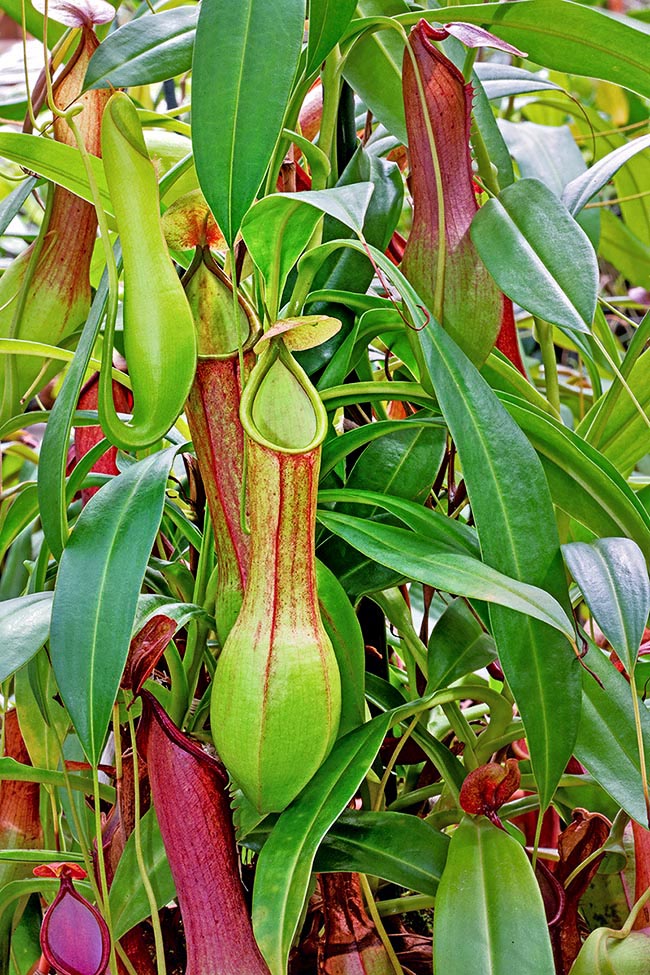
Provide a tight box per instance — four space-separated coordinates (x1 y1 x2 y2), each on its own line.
140 691 269 975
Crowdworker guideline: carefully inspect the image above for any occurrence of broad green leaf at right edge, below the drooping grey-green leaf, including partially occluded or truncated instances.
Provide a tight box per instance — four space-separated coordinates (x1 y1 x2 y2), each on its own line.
575 643 650 828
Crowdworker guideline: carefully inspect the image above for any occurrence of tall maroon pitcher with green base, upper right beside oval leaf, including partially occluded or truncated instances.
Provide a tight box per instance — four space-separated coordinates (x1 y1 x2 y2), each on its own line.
402 20 502 365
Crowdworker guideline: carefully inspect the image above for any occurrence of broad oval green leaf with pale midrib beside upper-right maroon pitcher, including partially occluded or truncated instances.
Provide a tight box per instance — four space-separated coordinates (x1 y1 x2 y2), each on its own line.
471 179 598 332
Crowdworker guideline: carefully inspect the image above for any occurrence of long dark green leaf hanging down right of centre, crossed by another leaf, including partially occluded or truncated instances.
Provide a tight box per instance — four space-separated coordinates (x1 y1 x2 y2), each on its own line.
419 325 580 806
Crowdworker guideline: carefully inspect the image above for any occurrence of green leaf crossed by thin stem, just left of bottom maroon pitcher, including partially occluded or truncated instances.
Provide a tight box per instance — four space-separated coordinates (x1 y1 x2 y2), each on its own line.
109 806 176 938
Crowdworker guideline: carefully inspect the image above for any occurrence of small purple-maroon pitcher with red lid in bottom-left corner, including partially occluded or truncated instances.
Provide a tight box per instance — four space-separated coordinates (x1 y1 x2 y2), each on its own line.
34 863 111 975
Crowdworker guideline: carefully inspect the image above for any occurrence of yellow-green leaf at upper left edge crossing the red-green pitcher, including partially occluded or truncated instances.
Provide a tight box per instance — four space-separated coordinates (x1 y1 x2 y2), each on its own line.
0 132 113 214
